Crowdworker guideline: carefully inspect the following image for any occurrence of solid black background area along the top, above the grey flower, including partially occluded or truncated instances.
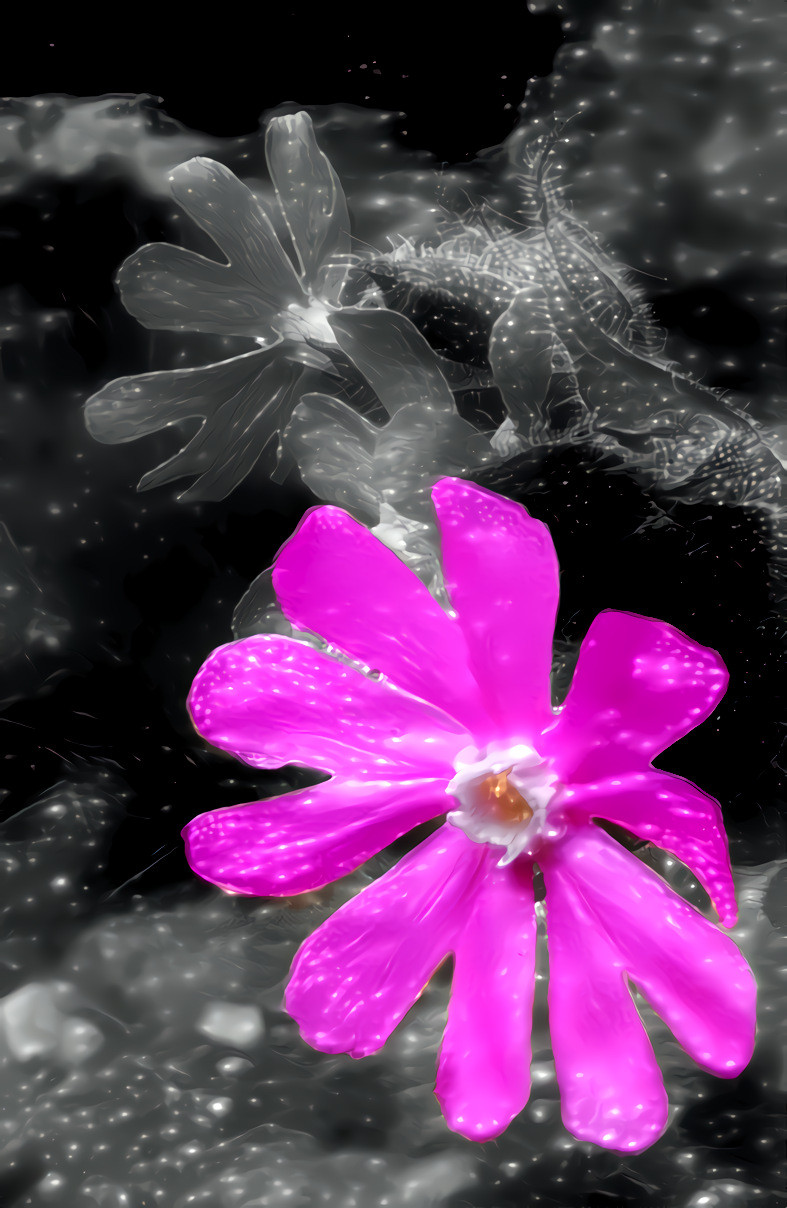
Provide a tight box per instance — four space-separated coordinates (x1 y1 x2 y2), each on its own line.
2 2 563 163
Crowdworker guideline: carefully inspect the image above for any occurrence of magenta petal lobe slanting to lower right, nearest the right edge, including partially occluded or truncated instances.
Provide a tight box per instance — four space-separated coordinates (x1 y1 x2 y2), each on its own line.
544 827 756 1078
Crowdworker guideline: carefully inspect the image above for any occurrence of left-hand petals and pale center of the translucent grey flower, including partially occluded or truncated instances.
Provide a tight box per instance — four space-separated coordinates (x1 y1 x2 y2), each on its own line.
86 112 349 499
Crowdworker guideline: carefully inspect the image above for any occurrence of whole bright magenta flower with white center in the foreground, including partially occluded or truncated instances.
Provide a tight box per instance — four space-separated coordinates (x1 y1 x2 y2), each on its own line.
184 478 754 1152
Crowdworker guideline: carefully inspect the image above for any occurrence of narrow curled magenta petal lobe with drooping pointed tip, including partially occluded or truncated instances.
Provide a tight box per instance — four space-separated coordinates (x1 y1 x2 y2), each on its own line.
562 769 737 927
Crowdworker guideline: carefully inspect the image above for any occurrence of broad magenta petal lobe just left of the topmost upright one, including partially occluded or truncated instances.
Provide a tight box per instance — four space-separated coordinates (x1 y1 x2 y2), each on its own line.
273 507 488 731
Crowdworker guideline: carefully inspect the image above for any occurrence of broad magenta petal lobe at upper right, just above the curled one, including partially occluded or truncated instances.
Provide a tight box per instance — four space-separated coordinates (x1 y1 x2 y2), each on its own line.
542 610 728 783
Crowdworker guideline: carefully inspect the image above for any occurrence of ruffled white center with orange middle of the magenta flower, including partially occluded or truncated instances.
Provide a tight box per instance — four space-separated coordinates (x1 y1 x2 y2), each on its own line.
446 743 562 867
